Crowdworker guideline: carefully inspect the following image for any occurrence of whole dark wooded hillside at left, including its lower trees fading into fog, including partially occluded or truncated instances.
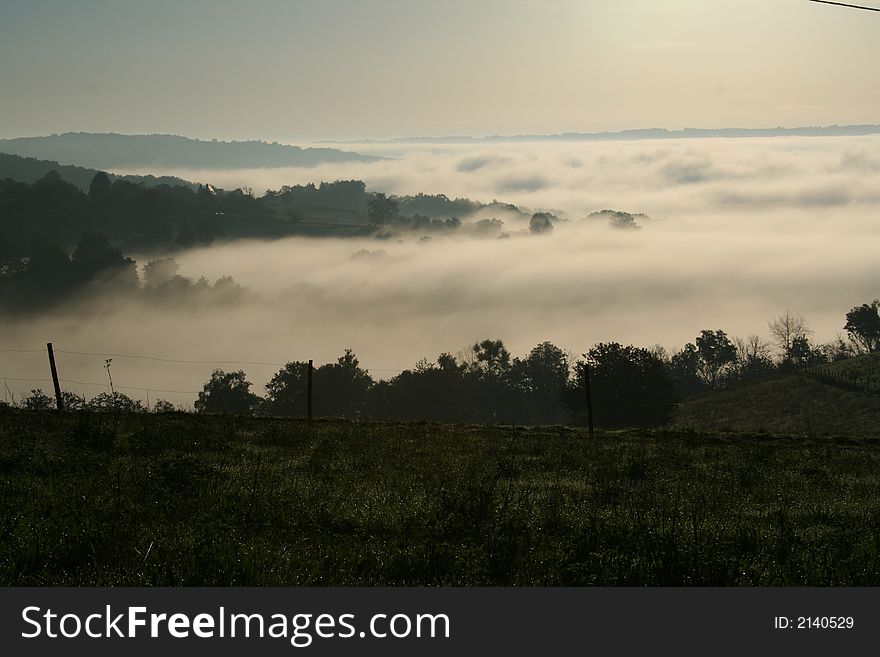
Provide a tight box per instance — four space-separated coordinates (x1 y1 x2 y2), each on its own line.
0 170 628 310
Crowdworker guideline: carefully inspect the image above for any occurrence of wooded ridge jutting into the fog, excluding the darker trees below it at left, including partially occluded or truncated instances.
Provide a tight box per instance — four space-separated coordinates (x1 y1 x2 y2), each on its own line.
0 170 529 266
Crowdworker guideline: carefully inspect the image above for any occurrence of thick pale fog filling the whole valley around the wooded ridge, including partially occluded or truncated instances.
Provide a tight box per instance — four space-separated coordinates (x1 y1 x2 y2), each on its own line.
0 137 880 402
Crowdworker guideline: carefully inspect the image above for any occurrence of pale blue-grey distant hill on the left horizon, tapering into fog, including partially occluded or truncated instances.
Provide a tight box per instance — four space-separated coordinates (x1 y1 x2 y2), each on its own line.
0 132 380 169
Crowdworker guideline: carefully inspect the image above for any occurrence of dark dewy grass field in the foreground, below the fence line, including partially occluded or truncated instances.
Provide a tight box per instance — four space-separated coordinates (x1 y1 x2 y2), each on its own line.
0 411 880 586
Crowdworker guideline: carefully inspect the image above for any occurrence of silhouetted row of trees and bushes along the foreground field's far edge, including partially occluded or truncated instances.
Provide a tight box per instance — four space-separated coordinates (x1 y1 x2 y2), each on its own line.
8 300 880 428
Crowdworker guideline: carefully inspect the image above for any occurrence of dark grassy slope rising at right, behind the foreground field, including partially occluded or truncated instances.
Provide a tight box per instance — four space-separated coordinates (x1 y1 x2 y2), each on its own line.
674 354 880 436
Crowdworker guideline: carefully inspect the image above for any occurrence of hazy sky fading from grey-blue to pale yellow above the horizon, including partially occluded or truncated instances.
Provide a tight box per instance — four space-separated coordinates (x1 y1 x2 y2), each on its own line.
0 0 880 141
